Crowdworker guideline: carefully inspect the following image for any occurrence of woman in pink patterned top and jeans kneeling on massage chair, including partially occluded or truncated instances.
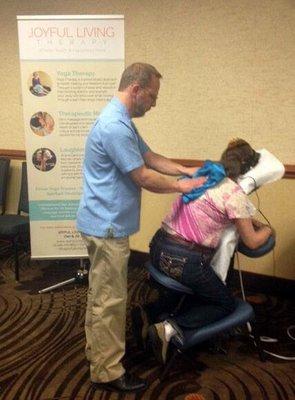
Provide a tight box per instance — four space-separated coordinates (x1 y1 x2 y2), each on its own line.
149 139 272 363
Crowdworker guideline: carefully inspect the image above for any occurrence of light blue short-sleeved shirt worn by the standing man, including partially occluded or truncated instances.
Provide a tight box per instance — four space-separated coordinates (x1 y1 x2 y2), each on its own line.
77 97 150 237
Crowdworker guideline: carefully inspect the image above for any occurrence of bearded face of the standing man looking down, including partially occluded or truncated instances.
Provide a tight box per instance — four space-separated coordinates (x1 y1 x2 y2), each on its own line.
132 76 160 117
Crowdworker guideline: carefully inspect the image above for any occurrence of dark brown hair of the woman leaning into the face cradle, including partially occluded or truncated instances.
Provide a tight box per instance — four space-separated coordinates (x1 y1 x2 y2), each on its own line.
220 139 260 180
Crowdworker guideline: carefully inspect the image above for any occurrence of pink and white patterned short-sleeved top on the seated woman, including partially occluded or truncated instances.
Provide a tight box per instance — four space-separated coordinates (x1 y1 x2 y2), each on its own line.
162 178 256 248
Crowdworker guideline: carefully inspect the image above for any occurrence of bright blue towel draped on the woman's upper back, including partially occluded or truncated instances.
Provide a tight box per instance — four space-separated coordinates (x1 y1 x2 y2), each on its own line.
182 160 226 204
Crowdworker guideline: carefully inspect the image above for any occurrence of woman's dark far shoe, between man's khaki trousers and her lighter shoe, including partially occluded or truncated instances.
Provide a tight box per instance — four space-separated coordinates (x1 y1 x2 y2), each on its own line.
131 306 150 351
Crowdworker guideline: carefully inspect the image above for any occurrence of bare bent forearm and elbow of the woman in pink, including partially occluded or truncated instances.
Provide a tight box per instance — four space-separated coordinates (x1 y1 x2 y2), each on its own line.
234 218 273 249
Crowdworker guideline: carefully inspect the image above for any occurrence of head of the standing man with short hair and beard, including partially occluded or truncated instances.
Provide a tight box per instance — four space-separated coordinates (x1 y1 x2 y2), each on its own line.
119 63 162 118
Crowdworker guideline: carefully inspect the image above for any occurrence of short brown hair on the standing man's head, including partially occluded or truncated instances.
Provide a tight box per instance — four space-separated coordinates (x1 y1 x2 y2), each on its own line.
119 63 162 91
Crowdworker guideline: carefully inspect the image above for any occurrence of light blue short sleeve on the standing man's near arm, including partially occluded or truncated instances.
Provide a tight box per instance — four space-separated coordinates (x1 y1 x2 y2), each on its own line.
102 122 148 174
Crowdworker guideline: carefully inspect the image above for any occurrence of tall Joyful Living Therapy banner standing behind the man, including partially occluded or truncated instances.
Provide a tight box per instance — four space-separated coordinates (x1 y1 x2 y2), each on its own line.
17 15 124 259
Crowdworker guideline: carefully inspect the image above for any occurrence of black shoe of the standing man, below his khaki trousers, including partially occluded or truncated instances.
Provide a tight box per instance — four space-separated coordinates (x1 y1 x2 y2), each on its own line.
92 372 147 392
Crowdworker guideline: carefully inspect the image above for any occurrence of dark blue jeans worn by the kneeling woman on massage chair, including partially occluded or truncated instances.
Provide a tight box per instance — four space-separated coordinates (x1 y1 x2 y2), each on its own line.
150 230 235 328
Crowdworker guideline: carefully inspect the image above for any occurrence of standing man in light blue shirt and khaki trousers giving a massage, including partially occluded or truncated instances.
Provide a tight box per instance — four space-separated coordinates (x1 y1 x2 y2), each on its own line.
77 63 203 392
